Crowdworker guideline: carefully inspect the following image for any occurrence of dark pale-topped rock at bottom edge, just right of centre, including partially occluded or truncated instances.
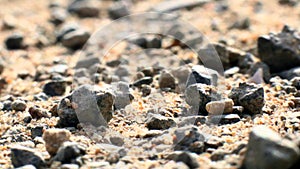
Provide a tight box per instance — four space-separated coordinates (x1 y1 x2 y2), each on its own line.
167 151 200 169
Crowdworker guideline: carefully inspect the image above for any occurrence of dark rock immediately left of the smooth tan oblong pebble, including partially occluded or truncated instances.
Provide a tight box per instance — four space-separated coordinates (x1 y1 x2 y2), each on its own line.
185 83 220 115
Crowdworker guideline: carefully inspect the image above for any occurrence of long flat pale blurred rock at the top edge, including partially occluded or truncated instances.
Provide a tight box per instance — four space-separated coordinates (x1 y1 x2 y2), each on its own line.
152 0 209 13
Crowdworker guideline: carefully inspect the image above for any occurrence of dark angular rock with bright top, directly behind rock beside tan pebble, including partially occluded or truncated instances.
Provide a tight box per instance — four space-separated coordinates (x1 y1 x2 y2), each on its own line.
186 65 218 87
